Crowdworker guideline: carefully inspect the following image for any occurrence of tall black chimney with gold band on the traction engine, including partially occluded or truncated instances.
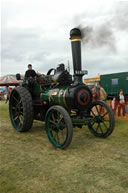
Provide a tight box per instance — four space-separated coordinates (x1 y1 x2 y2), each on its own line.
70 28 87 84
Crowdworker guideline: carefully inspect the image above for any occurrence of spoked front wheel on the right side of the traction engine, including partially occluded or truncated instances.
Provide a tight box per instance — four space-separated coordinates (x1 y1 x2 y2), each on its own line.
88 101 115 138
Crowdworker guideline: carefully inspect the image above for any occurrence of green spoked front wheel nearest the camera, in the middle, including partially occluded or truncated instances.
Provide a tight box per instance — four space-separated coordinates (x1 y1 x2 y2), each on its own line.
45 105 73 149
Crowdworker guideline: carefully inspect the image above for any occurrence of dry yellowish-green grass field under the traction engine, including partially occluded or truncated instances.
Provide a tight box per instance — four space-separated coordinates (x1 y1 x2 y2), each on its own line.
0 104 128 193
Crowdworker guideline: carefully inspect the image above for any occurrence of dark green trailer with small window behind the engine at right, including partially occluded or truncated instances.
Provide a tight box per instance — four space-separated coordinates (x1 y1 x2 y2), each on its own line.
100 72 128 98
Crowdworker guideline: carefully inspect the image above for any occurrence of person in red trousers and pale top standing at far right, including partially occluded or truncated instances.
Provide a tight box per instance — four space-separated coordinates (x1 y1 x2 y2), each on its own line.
117 89 125 117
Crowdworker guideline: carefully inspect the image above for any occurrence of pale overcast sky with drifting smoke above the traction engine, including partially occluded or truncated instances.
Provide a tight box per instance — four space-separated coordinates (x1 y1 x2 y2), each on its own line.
0 0 128 77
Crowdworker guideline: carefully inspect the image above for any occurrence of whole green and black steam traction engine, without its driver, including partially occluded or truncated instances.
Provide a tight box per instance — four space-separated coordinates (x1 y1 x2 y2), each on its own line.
9 28 114 149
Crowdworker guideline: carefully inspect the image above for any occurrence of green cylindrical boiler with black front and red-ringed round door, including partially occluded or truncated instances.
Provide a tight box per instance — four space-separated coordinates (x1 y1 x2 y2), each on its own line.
40 84 92 110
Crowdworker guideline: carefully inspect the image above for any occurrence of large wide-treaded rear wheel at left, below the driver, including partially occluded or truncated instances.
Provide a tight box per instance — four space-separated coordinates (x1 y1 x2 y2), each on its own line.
9 87 33 132
